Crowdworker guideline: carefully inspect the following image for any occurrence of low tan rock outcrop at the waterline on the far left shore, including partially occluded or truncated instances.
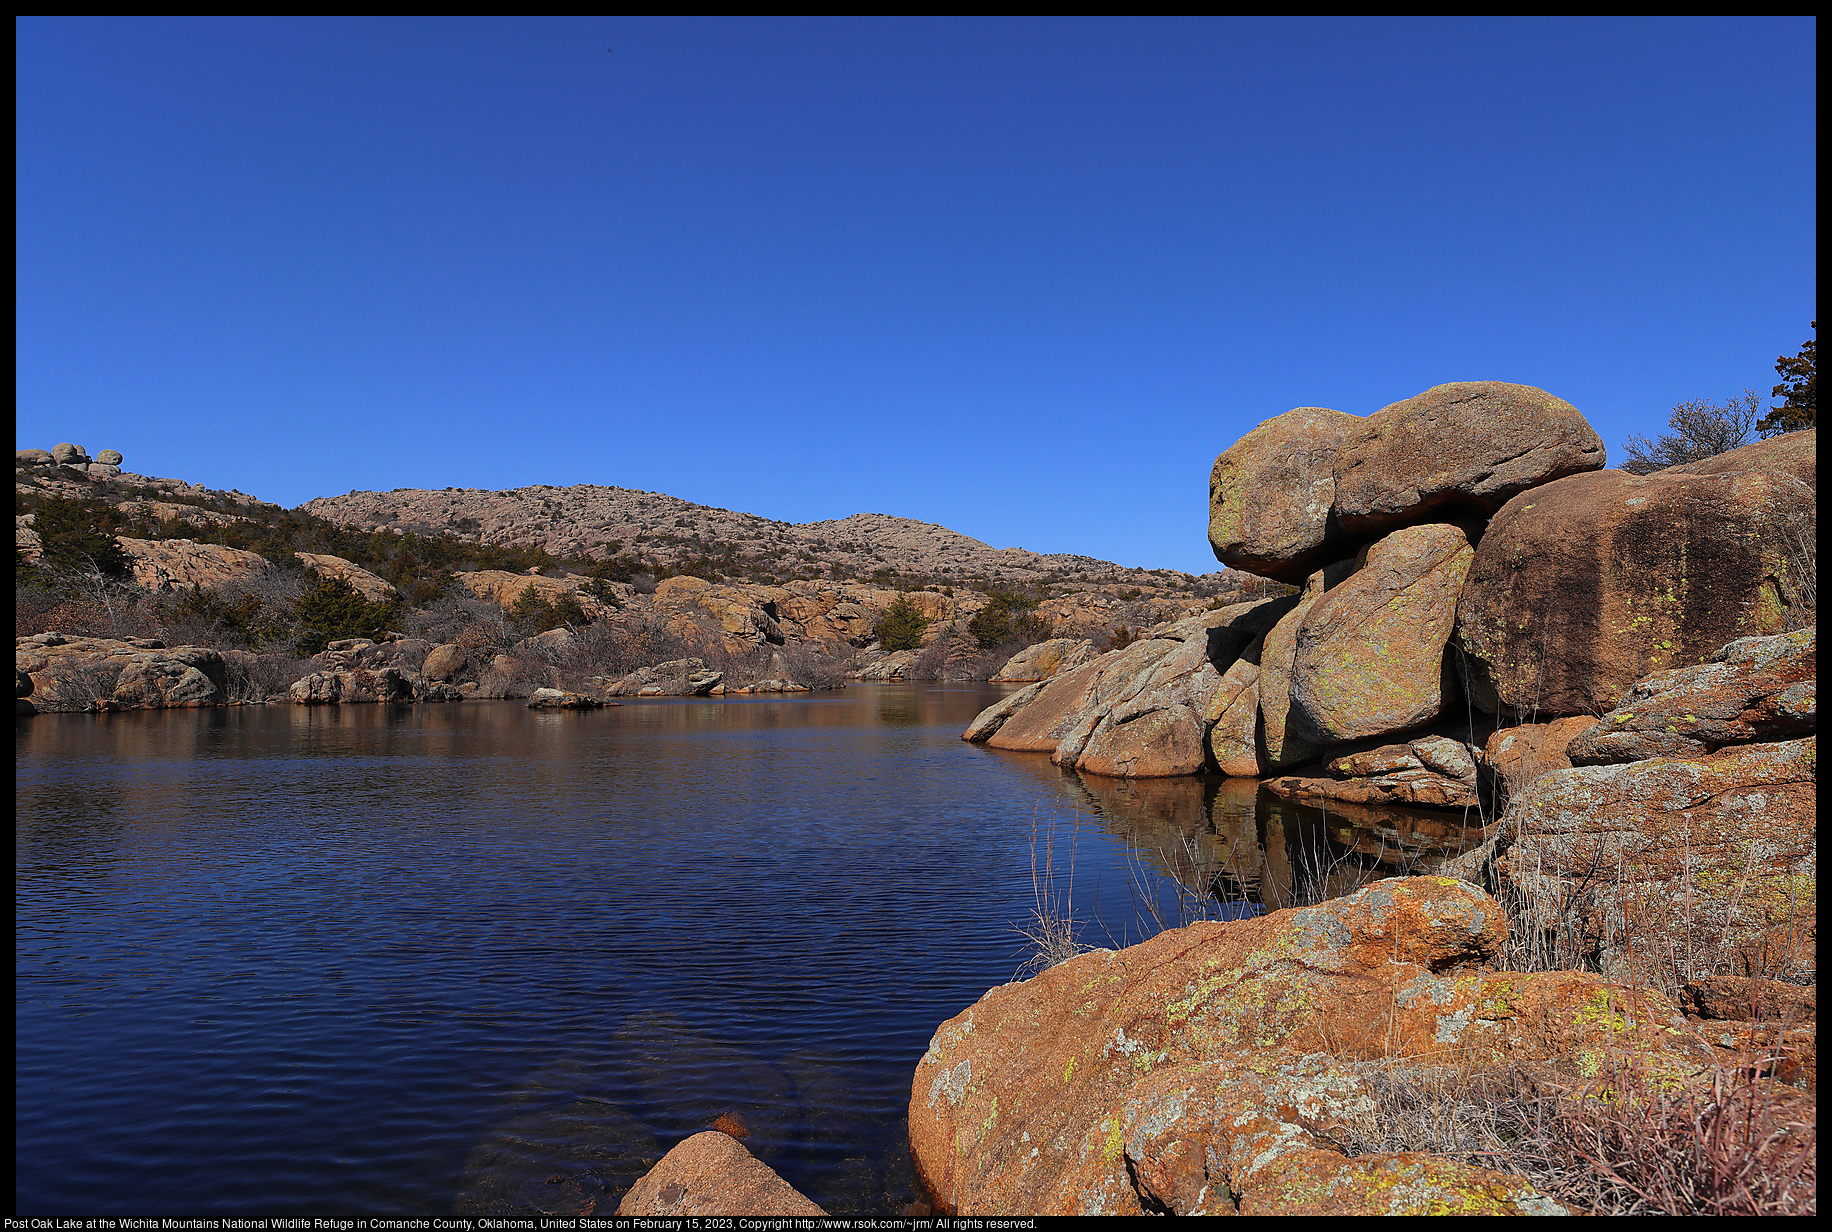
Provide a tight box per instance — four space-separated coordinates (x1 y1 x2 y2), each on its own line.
15 633 227 713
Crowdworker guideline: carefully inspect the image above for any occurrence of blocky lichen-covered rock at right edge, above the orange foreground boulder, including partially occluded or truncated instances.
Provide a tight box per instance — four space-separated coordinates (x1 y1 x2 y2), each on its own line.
1495 737 1817 981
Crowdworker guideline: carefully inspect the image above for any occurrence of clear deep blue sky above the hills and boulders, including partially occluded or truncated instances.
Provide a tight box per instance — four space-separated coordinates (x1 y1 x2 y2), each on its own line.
16 18 1816 572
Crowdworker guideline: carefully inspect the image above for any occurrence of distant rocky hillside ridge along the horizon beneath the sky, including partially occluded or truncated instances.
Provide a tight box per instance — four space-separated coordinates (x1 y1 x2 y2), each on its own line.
300 484 1226 594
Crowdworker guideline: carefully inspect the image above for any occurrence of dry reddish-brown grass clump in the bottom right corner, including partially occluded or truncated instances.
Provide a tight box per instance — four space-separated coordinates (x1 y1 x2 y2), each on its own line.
1328 1060 1819 1216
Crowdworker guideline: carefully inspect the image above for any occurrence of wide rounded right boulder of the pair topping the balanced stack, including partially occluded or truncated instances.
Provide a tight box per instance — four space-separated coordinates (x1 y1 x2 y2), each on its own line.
1330 381 1605 535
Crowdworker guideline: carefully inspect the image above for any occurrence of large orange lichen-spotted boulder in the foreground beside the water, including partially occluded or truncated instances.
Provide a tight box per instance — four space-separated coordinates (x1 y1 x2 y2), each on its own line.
909 878 1711 1216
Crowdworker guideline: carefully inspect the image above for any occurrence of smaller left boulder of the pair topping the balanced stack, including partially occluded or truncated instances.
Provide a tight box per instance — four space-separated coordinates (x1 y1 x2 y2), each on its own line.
1209 407 1363 583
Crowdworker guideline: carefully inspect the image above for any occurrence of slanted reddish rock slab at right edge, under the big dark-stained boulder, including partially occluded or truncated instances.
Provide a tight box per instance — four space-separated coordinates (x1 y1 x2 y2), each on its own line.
1568 629 1817 766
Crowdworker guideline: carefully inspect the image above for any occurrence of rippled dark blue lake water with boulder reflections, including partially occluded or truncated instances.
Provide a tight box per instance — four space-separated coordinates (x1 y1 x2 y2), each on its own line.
15 686 1472 1216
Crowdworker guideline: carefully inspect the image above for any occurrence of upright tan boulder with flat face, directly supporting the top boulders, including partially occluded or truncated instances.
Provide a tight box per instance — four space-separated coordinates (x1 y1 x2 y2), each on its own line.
1288 523 1475 746
